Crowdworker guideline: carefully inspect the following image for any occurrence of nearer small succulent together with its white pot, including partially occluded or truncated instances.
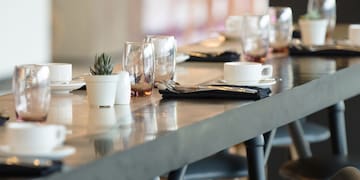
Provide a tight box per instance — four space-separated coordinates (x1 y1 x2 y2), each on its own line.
85 53 118 107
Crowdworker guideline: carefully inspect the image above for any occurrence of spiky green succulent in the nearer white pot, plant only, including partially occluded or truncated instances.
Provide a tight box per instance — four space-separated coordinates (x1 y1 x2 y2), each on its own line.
90 53 114 75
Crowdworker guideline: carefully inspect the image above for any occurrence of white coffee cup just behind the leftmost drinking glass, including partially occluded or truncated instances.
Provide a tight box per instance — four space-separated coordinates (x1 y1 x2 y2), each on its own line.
46 63 72 84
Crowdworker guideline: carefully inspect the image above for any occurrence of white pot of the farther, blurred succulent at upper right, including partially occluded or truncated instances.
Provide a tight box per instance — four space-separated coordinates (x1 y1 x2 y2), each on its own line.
299 19 328 45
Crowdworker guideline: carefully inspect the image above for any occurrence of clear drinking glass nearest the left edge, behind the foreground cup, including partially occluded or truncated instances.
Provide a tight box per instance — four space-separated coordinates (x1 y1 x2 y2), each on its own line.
13 64 51 122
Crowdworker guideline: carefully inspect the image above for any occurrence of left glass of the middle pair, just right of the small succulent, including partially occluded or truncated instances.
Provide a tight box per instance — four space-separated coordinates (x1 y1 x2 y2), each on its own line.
122 42 155 96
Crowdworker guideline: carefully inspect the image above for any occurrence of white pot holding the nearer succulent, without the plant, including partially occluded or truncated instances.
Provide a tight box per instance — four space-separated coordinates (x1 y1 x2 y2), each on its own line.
85 75 119 107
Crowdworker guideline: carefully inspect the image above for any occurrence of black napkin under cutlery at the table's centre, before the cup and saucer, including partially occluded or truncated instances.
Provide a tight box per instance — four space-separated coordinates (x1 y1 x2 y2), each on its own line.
159 87 271 100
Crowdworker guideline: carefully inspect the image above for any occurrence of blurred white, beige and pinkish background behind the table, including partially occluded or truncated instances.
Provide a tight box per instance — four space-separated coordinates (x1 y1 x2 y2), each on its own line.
0 0 360 80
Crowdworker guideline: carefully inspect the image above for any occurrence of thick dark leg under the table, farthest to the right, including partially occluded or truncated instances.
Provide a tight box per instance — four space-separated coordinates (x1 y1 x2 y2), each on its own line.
329 101 348 155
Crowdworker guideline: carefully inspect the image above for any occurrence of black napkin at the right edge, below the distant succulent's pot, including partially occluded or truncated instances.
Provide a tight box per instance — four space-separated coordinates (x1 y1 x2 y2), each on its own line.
289 46 360 56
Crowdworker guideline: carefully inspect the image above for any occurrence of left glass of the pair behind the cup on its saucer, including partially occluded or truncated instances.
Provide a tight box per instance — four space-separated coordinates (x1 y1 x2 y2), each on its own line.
239 14 270 63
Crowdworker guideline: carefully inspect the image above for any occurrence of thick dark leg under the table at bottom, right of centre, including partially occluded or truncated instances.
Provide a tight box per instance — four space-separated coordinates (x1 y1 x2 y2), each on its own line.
245 135 266 180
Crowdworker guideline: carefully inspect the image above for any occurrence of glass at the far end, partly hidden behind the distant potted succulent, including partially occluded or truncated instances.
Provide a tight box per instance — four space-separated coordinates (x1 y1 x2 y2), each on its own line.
307 0 336 41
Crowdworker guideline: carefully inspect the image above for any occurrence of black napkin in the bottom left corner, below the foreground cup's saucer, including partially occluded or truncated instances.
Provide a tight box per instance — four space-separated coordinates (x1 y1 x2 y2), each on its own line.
0 161 62 179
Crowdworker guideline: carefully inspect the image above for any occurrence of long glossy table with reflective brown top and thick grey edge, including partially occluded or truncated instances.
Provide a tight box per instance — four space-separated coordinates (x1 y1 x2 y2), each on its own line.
0 53 360 180
